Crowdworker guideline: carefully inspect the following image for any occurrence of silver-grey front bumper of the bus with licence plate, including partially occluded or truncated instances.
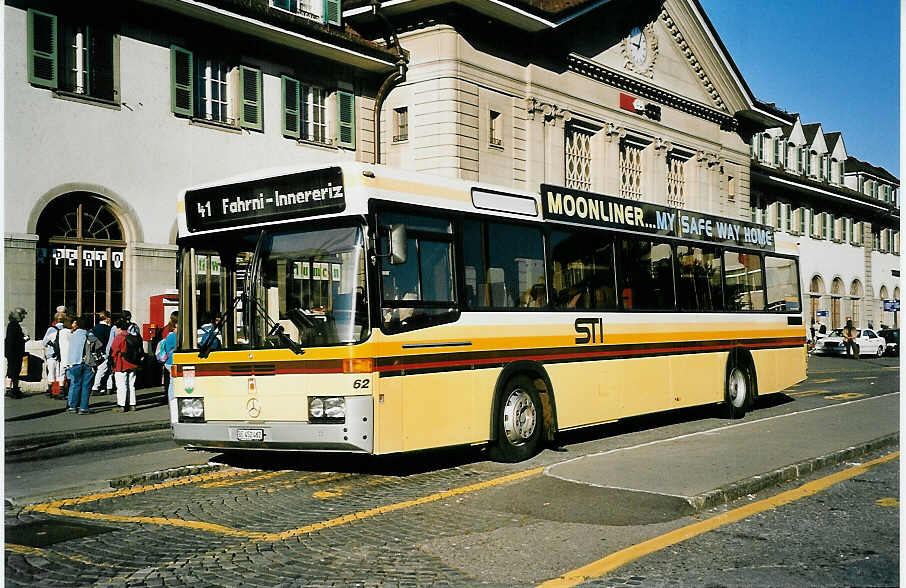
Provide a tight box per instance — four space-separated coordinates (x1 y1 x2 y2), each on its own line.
172 396 374 453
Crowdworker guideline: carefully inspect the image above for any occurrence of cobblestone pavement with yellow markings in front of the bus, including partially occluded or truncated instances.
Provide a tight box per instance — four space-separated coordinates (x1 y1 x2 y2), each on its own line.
6 458 544 586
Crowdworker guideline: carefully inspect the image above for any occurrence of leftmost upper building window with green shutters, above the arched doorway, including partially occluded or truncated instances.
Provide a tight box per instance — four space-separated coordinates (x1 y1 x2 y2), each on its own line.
27 9 117 100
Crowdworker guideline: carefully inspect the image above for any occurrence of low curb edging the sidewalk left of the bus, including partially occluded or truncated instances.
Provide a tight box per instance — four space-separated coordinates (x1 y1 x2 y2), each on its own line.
5 421 175 463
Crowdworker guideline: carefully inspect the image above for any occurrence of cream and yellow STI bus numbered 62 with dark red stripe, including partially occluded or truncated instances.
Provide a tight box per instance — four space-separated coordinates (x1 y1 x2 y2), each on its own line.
171 163 806 461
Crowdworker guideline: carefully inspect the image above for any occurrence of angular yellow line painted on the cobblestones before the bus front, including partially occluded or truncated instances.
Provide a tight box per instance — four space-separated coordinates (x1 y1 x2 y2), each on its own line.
26 467 544 542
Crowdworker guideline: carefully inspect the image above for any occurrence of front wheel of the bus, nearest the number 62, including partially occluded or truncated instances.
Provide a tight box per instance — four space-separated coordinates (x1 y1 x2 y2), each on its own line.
489 375 544 463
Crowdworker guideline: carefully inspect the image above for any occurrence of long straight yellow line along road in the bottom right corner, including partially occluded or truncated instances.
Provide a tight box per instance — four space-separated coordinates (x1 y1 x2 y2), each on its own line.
539 451 900 588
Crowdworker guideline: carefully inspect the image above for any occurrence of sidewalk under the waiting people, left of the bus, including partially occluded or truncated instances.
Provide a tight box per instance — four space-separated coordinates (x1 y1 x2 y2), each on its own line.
3 382 170 462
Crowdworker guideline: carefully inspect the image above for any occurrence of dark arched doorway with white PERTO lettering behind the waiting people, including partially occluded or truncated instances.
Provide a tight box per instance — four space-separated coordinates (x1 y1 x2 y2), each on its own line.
35 192 126 328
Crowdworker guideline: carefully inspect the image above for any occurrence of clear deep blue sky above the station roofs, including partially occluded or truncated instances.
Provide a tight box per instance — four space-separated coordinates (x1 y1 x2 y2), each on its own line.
700 0 900 177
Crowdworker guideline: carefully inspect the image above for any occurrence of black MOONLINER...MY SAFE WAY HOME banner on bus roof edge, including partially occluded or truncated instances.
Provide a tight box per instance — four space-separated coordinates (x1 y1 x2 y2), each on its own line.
541 184 774 251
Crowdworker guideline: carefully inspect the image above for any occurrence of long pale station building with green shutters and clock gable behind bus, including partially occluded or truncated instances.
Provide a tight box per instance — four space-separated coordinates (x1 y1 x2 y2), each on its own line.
4 0 899 344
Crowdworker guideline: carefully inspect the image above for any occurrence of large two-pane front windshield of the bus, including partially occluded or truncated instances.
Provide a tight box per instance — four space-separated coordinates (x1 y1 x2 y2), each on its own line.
180 220 369 352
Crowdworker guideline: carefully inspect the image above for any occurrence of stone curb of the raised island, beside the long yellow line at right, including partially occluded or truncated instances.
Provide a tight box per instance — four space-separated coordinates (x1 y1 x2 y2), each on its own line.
686 433 900 512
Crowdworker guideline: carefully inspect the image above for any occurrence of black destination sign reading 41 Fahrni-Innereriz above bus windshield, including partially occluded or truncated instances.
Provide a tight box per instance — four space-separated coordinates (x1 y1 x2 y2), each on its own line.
185 167 346 232
